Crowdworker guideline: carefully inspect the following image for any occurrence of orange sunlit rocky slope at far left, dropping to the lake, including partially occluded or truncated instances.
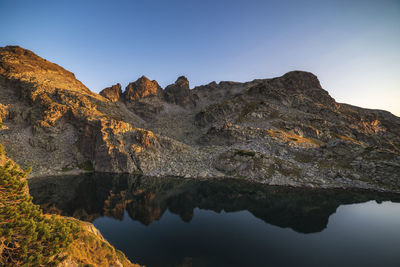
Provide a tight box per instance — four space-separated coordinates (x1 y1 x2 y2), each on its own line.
0 47 164 176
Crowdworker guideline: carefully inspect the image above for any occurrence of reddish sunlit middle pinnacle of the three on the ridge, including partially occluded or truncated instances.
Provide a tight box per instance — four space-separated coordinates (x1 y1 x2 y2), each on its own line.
123 75 162 102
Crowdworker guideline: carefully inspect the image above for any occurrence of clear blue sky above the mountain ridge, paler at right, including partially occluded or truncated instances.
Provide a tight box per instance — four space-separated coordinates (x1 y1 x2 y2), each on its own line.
0 0 400 116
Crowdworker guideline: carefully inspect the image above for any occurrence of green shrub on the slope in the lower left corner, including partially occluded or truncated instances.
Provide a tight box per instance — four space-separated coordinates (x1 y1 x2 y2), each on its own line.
0 161 80 266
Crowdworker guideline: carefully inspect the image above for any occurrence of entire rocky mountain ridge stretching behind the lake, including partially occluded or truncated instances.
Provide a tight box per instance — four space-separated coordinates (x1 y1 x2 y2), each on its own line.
0 46 400 192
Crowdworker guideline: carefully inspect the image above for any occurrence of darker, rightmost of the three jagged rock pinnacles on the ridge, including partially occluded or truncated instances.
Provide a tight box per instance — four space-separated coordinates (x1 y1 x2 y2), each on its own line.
164 76 196 107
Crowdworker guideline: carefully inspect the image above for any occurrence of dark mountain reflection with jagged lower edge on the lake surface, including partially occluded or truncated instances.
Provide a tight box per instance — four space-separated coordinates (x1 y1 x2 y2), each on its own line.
29 174 400 233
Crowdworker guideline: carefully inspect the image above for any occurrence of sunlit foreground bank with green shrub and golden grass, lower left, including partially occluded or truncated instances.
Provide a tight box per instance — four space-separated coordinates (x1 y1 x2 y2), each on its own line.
0 144 137 266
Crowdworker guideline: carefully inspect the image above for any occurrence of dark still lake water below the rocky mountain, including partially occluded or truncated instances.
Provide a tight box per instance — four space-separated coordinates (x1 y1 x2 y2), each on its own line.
29 174 400 267
